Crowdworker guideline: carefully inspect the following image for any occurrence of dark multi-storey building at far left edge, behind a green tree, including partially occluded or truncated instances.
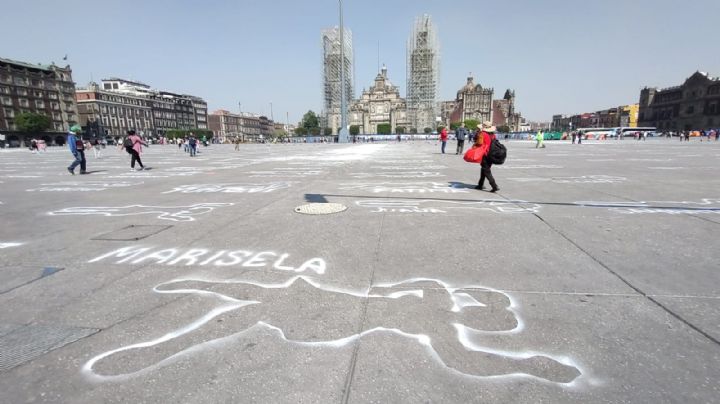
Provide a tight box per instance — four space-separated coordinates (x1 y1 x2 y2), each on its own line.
0 58 78 132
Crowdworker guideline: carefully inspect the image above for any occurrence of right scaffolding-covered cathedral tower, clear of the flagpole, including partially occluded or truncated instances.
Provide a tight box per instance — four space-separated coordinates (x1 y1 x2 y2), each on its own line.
407 14 440 132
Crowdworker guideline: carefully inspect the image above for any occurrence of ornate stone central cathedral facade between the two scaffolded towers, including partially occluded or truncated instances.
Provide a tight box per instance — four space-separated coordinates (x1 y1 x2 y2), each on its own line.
348 66 411 134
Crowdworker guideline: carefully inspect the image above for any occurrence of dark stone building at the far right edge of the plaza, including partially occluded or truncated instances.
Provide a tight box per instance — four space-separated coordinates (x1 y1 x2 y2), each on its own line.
638 72 720 131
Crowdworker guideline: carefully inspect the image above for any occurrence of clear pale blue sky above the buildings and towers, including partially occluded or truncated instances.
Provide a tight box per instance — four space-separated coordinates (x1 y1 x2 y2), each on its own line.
0 0 720 123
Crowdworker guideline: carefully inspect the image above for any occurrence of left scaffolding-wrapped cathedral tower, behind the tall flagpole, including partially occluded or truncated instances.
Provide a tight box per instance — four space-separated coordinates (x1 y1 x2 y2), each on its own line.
321 27 354 135
